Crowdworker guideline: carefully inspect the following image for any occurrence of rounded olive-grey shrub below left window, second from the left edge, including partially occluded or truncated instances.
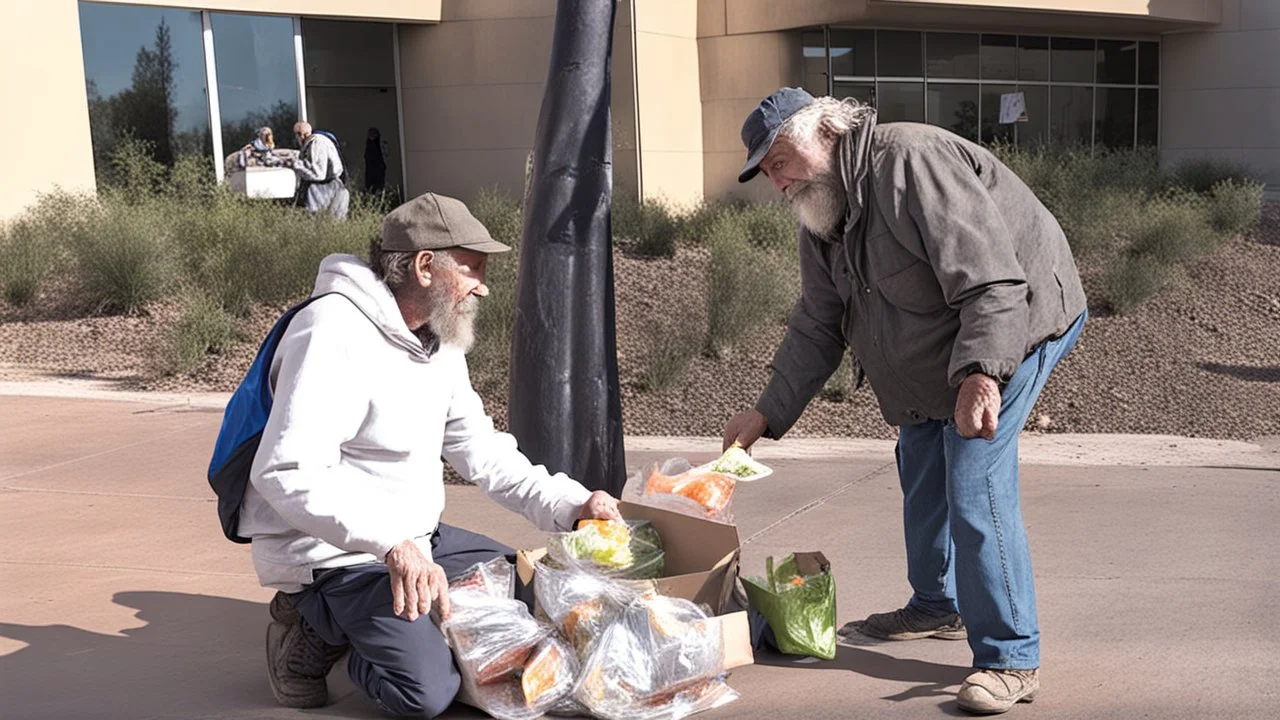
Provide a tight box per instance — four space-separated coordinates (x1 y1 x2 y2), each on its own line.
69 201 178 313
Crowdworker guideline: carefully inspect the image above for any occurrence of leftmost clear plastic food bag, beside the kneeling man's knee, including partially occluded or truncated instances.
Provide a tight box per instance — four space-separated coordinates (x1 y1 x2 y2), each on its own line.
442 559 579 720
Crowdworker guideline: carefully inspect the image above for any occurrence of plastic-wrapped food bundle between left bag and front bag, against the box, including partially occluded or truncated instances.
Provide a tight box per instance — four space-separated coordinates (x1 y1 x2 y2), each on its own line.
534 564 657 657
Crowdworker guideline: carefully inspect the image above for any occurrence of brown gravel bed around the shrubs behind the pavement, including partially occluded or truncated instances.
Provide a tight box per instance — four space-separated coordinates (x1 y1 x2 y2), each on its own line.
0 204 1280 439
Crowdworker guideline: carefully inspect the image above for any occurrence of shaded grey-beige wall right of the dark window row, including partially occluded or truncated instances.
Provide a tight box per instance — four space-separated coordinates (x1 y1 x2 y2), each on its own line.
1160 0 1280 192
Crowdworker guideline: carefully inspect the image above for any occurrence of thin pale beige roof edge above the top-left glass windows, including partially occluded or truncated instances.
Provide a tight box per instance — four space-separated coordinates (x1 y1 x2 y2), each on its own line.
83 0 440 23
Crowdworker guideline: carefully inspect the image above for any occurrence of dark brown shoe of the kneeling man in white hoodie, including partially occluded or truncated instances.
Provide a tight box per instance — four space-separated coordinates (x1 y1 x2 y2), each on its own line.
266 601 347 708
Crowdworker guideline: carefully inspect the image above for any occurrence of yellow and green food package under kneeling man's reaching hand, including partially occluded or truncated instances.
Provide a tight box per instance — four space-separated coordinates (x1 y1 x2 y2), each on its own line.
547 520 666 579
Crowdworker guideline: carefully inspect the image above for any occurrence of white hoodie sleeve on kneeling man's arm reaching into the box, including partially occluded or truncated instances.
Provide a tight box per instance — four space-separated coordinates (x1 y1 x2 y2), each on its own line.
444 355 591 532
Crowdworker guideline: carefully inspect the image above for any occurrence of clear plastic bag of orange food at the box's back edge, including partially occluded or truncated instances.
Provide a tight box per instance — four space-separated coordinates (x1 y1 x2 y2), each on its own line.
623 457 737 523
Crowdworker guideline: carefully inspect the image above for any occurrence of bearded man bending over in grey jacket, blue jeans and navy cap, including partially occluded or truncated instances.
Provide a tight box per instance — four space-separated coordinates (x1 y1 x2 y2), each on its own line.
724 88 1087 714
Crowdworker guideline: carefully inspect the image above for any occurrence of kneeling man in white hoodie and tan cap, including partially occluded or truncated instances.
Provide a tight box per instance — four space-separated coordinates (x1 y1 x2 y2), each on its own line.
239 193 621 717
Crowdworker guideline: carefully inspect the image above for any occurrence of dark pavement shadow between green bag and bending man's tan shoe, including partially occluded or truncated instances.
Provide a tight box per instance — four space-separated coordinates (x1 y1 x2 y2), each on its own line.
755 642 973 702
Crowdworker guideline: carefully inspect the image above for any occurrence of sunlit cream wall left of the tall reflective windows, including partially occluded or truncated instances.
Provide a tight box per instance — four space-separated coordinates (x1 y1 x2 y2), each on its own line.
0 0 93 222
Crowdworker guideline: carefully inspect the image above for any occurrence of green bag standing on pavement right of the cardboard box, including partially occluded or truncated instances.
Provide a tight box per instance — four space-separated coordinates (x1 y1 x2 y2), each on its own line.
742 552 836 660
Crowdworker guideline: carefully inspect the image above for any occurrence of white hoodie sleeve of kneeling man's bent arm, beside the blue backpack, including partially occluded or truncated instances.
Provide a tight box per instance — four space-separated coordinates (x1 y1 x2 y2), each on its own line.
250 296 414 559
